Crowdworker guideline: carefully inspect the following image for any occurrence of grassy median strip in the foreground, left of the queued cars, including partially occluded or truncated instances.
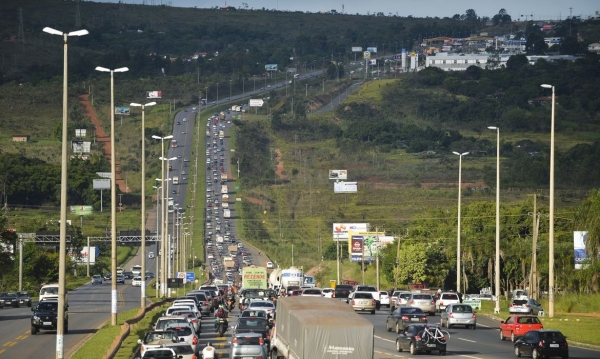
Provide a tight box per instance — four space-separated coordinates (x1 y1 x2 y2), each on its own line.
71 308 140 359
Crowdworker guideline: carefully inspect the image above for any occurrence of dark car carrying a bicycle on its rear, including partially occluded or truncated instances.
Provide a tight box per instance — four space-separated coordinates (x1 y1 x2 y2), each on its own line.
396 324 448 355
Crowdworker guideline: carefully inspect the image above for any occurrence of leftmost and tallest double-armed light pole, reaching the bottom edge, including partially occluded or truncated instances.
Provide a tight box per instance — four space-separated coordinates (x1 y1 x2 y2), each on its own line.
42 27 88 359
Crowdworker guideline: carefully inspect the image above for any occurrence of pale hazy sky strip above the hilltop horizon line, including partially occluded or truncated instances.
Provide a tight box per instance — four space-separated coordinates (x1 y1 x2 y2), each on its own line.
95 0 600 20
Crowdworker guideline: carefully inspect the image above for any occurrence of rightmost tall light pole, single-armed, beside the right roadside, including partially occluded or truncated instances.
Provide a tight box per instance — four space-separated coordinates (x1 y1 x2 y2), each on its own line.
541 84 555 318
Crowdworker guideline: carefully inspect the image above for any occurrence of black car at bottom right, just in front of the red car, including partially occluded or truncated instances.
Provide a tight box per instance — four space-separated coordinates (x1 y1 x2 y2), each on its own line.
515 329 569 359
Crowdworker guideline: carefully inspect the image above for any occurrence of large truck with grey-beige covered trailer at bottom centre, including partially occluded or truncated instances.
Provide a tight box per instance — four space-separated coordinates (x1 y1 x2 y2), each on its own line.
268 297 375 359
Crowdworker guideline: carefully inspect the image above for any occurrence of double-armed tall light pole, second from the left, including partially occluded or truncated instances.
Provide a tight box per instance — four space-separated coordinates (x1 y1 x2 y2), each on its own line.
96 66 129 325
